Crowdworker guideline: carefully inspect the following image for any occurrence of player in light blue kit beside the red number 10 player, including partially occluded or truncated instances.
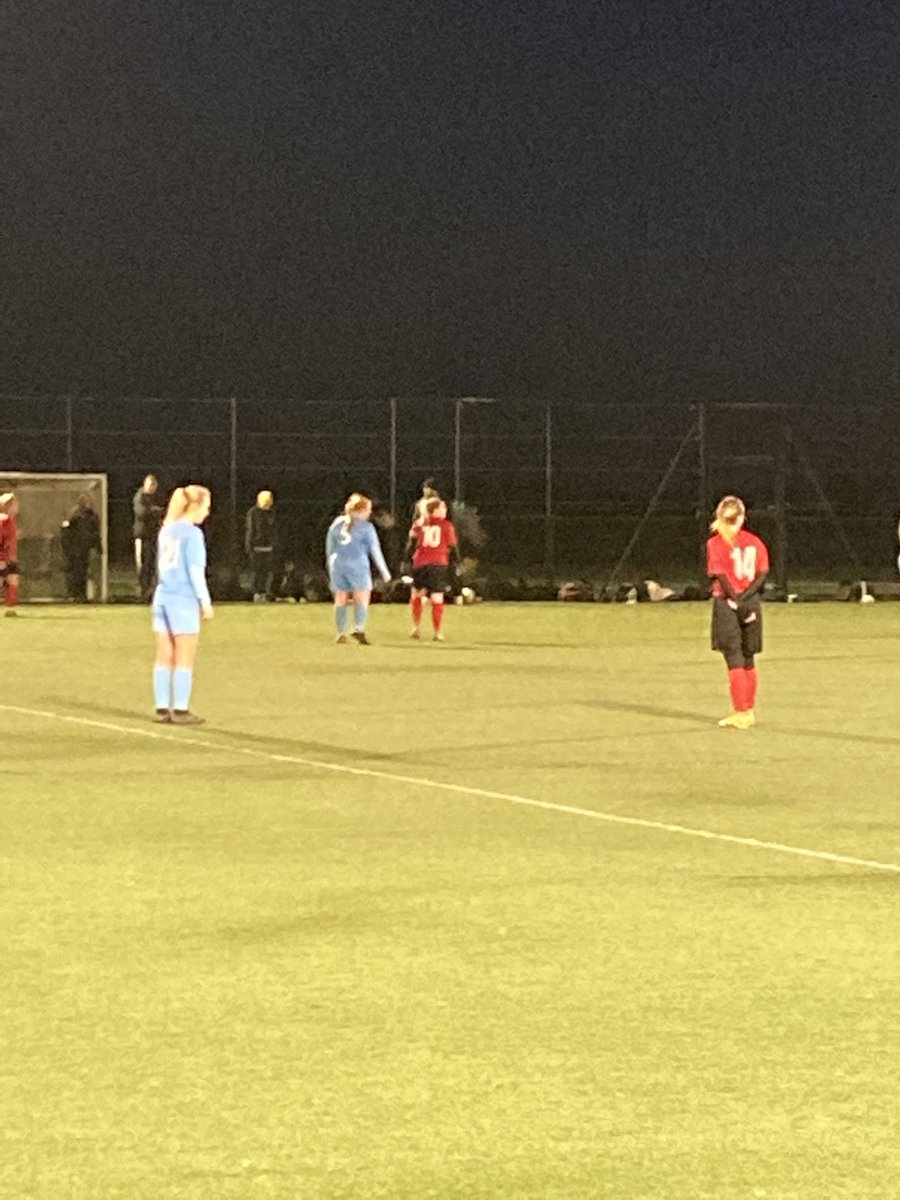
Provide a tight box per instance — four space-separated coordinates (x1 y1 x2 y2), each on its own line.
325 492 391 646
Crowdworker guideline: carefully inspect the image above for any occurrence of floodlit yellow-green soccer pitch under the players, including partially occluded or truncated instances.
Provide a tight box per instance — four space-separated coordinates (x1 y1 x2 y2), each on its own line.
0 604 900 1200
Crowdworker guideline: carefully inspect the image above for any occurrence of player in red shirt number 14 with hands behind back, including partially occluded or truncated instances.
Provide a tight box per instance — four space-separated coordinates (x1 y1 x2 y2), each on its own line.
707 496 769 730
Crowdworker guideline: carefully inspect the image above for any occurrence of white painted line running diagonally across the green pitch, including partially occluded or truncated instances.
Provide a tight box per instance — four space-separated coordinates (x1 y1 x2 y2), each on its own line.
7 704 900 875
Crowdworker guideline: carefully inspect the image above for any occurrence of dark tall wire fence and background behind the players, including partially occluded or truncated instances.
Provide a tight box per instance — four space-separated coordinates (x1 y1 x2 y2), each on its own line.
0 396 900 582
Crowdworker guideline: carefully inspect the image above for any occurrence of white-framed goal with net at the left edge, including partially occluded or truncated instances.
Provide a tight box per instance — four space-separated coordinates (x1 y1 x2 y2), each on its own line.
0 470 109 601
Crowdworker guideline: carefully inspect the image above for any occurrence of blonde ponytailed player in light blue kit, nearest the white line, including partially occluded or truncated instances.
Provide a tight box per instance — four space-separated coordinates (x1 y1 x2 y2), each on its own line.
152 484 212 725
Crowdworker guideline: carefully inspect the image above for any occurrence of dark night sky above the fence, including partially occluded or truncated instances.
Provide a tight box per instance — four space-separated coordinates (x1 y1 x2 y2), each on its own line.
0 0 900 402
